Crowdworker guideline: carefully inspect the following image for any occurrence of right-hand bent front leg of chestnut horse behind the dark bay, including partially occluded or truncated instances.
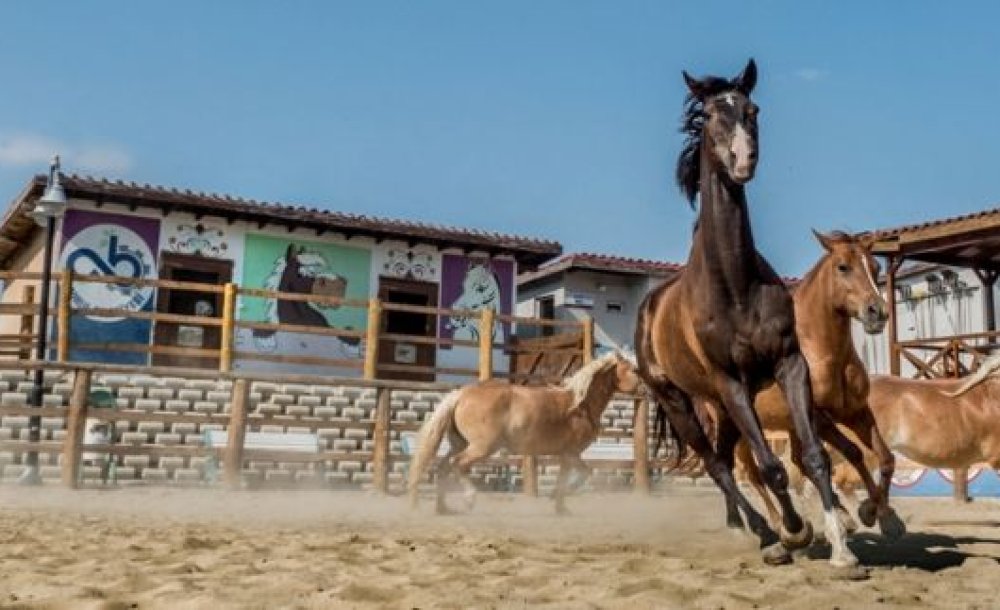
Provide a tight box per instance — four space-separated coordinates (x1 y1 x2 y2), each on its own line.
844 408 906 540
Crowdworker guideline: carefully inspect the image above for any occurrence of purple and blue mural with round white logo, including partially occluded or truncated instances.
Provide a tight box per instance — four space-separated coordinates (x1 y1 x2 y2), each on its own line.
59 210 160 364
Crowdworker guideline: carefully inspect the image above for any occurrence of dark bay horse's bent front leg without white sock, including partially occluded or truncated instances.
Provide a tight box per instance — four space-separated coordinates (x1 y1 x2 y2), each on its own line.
722 379 812 549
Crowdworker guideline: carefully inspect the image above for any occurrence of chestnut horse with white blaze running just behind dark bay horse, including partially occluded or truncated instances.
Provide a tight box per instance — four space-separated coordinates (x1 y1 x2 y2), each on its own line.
731 232 906 538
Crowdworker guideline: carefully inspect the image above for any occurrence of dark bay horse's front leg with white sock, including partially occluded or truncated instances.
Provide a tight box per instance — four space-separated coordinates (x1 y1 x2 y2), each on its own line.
775 353 858 567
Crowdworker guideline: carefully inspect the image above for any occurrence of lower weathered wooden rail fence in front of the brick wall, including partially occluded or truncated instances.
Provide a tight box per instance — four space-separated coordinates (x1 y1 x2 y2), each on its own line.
0 361 666 495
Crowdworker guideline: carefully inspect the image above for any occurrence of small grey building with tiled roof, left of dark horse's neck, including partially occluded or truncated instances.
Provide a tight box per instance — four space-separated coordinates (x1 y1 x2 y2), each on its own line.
517 253 683 351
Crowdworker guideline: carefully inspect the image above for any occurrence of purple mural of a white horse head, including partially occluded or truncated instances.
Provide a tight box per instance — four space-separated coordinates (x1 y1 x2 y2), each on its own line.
438 254 514 342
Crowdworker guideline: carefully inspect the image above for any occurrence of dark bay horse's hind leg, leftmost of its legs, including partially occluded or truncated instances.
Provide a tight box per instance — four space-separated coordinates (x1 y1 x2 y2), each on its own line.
657 384 792 565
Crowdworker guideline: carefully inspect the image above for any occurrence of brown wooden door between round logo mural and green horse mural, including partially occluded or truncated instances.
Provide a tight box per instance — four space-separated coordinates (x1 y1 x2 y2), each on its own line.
153 252 233 369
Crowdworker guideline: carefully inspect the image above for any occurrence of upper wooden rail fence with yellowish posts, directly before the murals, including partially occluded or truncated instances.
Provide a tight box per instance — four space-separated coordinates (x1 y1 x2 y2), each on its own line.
0 270 594 382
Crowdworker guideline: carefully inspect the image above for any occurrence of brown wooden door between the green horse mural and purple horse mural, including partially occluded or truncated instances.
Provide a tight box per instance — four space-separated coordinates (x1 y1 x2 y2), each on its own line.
378 278 438 381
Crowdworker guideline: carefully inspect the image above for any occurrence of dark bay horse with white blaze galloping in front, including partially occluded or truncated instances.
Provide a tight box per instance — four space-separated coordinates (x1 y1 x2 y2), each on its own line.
635 60 857 566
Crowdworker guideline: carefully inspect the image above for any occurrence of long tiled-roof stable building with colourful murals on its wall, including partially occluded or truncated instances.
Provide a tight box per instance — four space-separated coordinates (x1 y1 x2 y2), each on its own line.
0 175 562 379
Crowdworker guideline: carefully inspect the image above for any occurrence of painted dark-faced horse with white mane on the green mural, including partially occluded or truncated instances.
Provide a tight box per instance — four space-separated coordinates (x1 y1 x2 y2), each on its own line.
253 244 361 358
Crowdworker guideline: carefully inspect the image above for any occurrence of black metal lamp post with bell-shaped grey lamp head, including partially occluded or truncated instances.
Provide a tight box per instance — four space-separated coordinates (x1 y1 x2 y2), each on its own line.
19 155 67 485
